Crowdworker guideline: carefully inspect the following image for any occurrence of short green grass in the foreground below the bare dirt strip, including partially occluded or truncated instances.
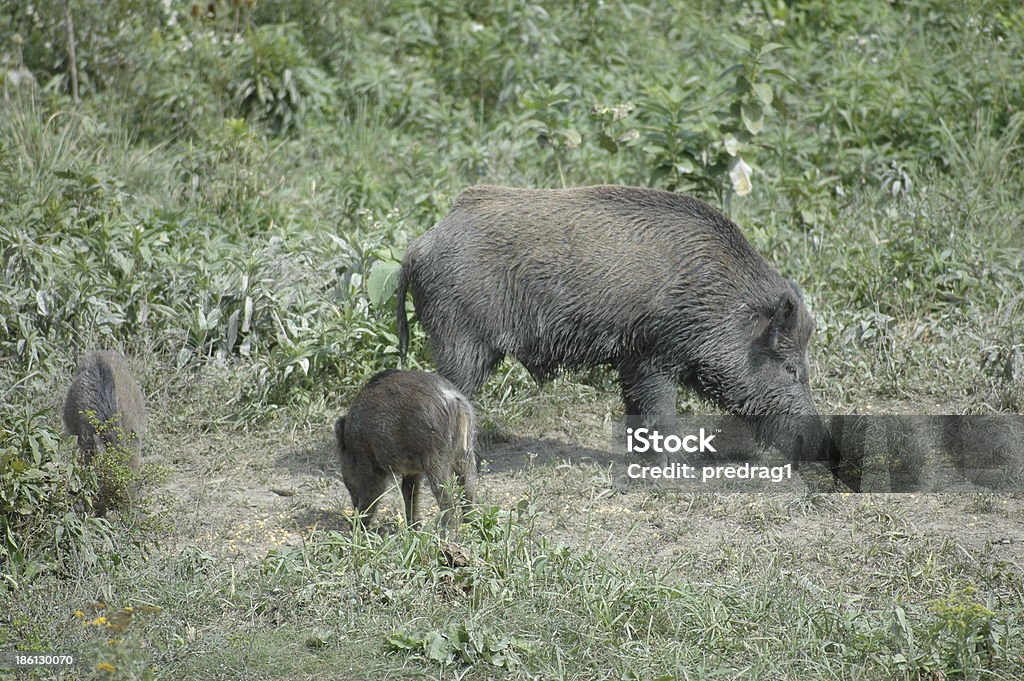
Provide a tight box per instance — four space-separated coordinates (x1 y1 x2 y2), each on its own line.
4 496 1024 679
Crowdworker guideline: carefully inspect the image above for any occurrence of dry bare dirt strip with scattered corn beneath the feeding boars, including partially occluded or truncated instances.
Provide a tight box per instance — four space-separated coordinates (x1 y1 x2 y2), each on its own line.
145 372 1024 592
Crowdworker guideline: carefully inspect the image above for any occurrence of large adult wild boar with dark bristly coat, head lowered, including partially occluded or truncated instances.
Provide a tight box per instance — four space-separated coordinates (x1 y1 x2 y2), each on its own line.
397 186 831 459
